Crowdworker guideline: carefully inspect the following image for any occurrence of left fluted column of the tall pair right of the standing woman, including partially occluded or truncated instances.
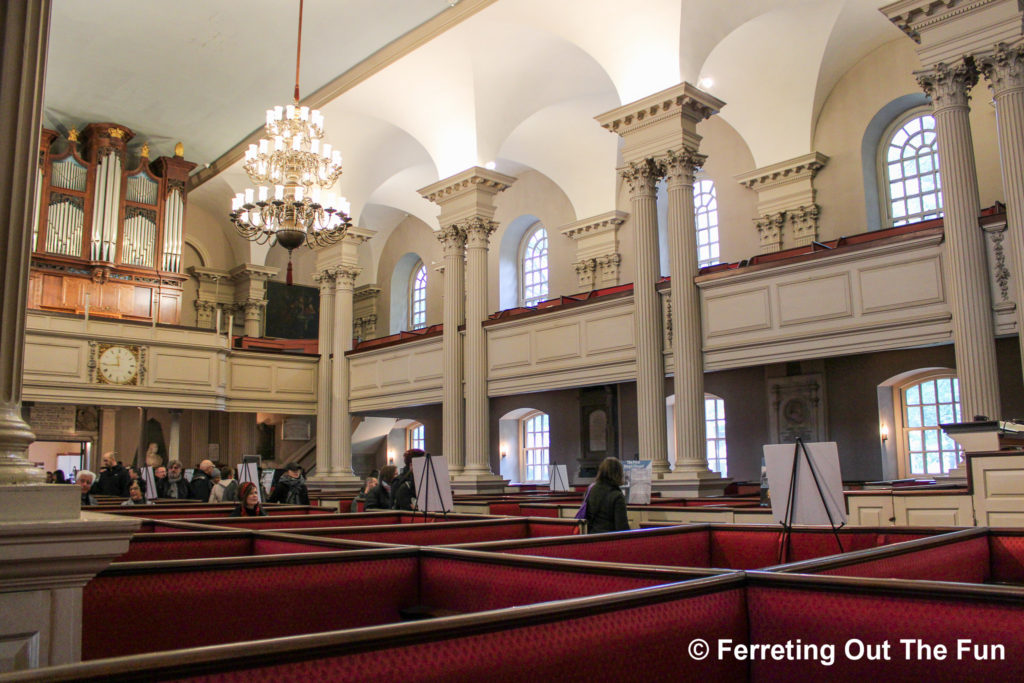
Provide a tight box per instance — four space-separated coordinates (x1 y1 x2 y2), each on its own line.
621 159 669 475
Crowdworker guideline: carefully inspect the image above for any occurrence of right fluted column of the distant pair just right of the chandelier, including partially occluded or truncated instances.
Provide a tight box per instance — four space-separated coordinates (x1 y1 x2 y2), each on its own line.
331 266 360 481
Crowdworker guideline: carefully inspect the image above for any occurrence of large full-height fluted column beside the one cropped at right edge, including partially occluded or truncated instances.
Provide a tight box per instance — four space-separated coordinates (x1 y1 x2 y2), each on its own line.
918 61 1000 420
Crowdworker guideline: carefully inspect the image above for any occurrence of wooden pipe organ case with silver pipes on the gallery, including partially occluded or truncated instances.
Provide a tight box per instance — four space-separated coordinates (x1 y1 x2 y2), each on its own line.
29 123 196 325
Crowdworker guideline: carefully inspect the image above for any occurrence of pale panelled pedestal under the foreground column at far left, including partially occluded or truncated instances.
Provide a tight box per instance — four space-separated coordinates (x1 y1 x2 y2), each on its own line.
0 484 140 673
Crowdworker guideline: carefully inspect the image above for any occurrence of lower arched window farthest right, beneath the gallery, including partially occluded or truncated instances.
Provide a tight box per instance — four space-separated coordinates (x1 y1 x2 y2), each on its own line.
899 374 961 476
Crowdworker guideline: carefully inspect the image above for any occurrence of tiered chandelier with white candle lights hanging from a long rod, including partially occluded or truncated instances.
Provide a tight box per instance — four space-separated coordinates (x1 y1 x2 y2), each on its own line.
229 0 352 285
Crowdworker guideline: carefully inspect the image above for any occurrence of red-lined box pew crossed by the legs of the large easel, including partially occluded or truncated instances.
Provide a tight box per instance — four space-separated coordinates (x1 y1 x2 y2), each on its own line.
452 524 946 569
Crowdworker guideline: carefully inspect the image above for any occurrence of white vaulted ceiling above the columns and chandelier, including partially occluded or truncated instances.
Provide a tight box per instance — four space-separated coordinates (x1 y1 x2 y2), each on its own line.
45 0 905 266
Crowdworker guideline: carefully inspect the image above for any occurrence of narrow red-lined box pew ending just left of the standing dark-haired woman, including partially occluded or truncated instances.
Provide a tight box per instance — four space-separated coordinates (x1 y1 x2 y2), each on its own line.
281 517 580 546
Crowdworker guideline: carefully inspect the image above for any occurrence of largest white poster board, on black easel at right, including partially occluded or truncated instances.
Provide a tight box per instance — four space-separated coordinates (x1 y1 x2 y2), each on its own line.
764 441 846 526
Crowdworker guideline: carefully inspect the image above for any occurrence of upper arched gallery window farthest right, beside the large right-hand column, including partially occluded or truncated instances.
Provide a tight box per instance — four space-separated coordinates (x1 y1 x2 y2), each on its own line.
880 108 942 227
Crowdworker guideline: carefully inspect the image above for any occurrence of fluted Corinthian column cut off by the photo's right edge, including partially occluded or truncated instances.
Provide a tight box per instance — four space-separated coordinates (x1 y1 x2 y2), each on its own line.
978 44 1024 385
